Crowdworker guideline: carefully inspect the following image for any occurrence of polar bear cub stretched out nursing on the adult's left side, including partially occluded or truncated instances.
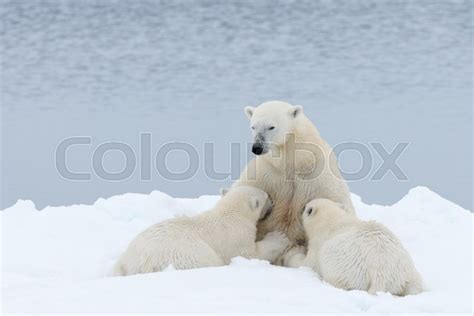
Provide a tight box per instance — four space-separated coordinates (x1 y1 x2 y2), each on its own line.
113 186 289 275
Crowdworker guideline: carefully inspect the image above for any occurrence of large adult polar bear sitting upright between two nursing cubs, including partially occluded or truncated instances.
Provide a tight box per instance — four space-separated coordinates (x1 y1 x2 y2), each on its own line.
234 101 354 243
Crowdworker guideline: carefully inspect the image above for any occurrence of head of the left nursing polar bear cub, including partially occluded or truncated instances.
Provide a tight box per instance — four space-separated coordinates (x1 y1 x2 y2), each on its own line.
221 185 273 222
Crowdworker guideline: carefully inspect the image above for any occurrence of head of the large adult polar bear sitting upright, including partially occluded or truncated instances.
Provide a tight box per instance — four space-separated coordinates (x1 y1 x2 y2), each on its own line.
245 101 303 155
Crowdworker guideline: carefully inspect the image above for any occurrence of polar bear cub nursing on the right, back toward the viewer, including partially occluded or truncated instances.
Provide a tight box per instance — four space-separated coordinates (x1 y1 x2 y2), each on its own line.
284 199 422 296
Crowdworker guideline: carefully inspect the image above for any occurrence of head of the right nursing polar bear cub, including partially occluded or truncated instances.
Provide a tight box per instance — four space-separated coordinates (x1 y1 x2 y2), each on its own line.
302 199 348 232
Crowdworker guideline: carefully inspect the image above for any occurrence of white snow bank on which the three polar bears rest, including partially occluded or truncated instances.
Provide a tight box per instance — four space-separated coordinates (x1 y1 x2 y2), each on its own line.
0 187 473 313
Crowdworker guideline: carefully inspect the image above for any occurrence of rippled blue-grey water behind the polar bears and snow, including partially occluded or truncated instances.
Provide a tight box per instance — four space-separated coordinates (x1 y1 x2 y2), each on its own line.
0 0 473 209
